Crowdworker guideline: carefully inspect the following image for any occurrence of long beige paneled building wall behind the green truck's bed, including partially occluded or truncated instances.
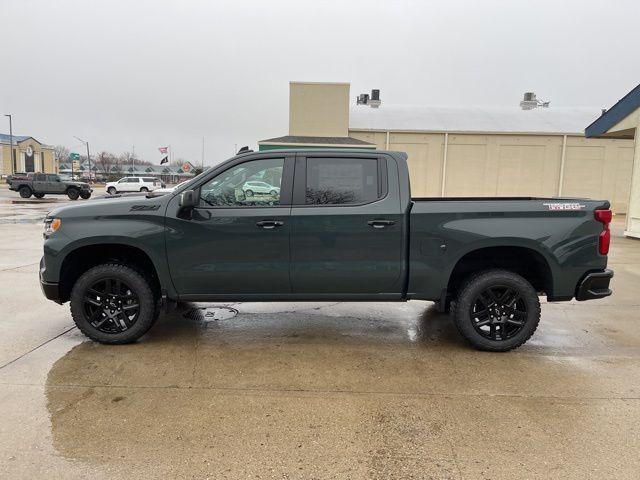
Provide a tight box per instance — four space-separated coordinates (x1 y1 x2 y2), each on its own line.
349 130 633 213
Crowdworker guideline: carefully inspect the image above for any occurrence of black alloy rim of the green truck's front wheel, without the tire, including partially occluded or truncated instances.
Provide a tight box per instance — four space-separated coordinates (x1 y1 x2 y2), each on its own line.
83 278 140 333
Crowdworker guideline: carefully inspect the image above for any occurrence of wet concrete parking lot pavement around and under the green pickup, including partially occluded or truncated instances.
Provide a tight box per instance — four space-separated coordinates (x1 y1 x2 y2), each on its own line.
0 185 640 479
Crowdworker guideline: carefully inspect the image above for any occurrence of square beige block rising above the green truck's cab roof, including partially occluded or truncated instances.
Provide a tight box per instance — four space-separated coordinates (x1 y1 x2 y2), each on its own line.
289 82 349 137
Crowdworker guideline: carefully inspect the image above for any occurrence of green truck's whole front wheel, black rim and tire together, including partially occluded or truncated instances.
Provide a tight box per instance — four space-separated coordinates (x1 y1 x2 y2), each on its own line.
71 263 159 344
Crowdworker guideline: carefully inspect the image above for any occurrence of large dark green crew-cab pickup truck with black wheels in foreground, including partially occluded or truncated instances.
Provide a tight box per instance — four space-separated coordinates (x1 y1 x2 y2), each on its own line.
40 150 613 351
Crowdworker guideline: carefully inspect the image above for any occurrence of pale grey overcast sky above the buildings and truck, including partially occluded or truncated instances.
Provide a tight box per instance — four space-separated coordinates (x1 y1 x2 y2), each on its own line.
0 0 640 165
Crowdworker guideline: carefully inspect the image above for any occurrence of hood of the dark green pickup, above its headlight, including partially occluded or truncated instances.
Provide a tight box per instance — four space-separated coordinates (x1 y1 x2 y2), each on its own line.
47 195 171 219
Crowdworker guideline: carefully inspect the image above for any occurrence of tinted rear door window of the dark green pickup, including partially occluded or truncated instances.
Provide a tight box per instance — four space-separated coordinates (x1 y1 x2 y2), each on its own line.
305 158 378 205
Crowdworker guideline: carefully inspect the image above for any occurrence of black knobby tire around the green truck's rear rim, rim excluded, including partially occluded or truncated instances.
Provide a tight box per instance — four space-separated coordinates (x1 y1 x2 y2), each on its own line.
452 269 540 352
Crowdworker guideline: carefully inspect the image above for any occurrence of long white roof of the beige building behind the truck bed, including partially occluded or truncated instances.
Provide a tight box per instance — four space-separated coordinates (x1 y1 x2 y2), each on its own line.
349 103 601 135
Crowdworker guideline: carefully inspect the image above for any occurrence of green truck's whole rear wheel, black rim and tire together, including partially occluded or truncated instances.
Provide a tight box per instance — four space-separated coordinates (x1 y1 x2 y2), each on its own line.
454 270 540 352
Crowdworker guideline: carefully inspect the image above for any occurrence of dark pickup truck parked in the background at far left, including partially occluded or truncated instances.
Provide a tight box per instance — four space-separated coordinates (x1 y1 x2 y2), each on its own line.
8 173 93 200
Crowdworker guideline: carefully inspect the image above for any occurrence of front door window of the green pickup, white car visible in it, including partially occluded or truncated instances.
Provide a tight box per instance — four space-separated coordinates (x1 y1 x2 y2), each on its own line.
200 158 284 207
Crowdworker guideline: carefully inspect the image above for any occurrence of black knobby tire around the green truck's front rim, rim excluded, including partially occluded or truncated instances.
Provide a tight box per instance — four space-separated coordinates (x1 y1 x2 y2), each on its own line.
71 263 160 344
